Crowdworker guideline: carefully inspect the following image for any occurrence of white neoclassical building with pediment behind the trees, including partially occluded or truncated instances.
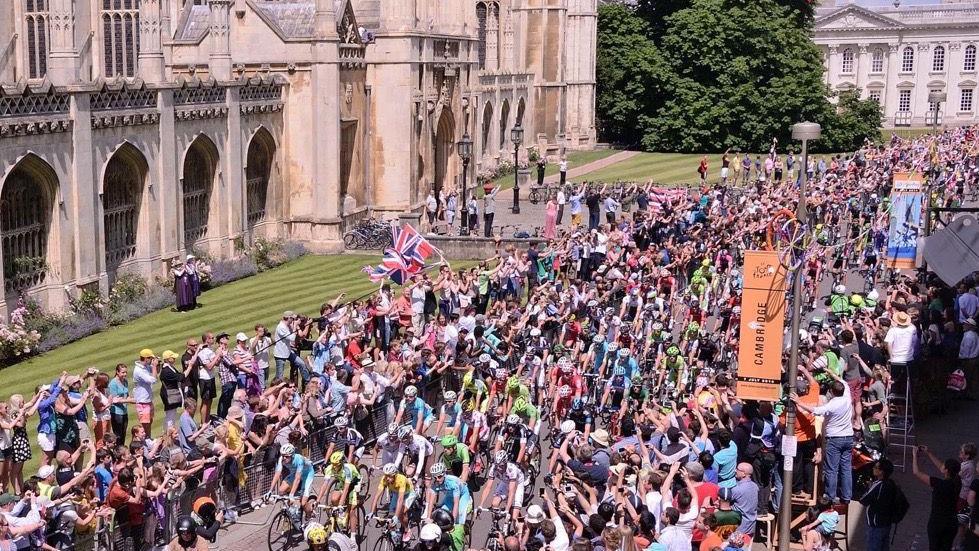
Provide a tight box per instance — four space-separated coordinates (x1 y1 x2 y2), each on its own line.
815 0 979 128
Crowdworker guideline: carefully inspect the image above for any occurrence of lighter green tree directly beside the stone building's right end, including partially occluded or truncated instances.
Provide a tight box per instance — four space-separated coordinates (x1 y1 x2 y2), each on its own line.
596 4 665 145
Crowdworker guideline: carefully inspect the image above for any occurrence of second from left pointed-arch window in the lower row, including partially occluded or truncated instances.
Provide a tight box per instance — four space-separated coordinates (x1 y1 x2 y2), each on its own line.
102 144 147 283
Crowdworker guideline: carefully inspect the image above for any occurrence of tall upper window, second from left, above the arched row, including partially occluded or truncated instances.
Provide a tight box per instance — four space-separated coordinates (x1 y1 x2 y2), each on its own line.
102 0 140 77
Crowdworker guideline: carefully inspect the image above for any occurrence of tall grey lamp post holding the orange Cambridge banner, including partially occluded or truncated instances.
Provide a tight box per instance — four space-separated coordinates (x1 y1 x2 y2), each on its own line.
778 122 822 551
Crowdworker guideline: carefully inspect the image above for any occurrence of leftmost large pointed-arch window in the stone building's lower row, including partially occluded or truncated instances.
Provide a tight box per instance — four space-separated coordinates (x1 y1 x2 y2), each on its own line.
0 155 58 292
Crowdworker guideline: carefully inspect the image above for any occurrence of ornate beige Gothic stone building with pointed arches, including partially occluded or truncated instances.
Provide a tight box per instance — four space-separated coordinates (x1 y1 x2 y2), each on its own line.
0 0 597 311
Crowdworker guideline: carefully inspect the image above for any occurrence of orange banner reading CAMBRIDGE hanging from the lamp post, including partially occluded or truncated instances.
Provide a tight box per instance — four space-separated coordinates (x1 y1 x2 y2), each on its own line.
737 251 786 400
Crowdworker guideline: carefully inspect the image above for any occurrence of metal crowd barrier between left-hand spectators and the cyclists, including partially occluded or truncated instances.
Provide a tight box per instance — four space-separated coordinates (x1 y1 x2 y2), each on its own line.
142 368 465 551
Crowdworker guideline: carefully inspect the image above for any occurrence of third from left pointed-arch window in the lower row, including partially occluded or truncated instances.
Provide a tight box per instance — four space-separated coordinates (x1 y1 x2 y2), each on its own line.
183 137 217 249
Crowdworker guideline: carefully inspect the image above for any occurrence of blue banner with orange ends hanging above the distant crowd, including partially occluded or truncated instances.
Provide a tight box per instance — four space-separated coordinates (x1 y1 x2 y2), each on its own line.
886 173 924 270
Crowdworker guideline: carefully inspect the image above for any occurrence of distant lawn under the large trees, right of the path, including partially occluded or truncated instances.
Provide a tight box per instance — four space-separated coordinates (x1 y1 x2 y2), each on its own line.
576 153 844 185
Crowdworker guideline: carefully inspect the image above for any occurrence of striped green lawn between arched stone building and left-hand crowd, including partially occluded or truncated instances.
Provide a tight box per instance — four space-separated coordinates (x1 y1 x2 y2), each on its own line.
0 255 472 477
